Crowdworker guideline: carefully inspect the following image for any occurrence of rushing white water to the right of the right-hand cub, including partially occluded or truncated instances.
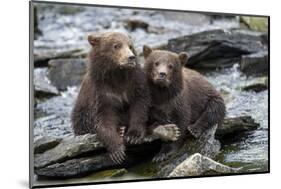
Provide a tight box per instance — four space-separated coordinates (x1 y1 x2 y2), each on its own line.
206 64 268 171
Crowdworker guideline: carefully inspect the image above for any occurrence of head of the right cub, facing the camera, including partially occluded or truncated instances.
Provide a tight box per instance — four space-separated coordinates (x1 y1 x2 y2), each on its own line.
143 45 188 87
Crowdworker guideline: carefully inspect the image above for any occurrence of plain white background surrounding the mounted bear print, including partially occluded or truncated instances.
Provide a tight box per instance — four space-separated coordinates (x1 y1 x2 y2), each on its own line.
0 0 276 189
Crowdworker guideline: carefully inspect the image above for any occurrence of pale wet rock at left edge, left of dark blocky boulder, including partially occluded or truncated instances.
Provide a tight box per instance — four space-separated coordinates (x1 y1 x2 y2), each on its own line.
34 68 59 98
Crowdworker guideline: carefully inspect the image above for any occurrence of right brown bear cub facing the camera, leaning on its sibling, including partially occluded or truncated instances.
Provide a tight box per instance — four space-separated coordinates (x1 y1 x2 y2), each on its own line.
143 46 225 161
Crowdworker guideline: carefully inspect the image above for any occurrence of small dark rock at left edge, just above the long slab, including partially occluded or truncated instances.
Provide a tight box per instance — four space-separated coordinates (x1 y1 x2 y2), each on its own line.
33 137 62 154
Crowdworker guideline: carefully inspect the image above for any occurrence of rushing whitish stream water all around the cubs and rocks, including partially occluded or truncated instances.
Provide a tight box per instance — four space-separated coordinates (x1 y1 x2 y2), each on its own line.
34 2 268 184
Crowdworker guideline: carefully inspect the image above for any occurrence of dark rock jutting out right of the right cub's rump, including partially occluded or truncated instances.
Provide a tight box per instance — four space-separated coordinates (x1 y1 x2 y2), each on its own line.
216 116 259 139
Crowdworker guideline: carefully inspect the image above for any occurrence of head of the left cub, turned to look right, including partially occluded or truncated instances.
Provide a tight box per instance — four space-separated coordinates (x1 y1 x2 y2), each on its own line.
88 32 137 68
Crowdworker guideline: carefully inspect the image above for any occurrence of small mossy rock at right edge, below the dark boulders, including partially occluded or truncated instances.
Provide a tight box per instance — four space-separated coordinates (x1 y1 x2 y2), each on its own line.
242 77 268 92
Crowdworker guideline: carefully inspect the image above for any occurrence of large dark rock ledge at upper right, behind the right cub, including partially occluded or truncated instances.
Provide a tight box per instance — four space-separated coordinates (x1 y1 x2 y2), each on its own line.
167 29 268 75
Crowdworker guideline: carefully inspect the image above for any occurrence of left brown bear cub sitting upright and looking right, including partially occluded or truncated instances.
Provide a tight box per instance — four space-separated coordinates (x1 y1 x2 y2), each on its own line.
71 32 150 163
